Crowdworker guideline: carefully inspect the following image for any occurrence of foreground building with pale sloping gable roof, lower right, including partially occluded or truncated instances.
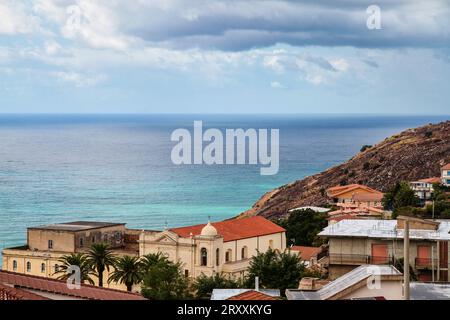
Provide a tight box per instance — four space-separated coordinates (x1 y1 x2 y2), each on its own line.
286 265 403 300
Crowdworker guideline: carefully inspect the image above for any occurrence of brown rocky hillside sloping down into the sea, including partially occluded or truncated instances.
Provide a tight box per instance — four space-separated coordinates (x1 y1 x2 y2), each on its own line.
239 121 450 217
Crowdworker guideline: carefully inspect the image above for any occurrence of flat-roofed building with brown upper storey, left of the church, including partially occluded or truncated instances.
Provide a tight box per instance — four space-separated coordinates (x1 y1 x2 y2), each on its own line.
2 221 140 290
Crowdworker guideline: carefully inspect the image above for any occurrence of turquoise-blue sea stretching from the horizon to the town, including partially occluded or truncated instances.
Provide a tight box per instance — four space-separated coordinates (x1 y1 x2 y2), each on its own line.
0 115 449 262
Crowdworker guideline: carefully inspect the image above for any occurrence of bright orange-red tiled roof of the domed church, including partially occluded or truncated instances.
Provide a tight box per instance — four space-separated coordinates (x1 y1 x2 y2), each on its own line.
170 216 286 242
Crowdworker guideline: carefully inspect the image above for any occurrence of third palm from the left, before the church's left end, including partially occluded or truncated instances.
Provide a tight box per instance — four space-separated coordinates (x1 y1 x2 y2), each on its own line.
108 256 142 292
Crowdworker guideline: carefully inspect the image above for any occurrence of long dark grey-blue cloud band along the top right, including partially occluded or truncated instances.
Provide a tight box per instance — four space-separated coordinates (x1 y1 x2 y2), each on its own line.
118 0 450 51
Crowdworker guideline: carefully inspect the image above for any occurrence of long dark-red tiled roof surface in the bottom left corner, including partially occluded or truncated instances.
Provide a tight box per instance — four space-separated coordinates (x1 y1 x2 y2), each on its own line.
0 271 146 300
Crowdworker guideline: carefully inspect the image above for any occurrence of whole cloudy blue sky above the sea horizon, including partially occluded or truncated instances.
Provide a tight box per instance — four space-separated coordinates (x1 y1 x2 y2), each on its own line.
0 0 450 114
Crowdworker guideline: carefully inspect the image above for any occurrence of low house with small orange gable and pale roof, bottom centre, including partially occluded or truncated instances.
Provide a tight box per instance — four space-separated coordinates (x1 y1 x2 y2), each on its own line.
211 289 280 300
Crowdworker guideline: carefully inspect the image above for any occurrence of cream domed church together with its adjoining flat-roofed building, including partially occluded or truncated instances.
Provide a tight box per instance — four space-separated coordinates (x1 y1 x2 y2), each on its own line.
2 217 286 290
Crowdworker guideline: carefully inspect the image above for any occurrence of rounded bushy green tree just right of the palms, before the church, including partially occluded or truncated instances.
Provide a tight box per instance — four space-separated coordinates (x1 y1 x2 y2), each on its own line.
141 259 191 300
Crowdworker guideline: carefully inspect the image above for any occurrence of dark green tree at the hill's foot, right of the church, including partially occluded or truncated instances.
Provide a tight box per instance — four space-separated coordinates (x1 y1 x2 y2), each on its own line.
277 209 328 246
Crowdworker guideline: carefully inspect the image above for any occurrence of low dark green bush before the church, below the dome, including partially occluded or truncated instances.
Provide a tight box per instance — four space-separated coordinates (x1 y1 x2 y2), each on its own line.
193 273 241 299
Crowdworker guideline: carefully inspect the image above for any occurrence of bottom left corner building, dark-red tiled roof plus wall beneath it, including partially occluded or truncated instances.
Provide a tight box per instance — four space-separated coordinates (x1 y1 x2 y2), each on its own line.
0 270 146 300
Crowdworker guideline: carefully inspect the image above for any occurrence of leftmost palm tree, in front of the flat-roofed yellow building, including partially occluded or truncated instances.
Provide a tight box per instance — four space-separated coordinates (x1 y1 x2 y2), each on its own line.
53 253 94 284
